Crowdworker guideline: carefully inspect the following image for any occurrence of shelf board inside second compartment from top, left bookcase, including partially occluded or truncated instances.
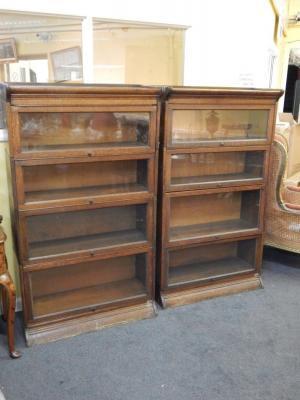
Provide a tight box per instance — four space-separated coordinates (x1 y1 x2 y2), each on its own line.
25 183 147 203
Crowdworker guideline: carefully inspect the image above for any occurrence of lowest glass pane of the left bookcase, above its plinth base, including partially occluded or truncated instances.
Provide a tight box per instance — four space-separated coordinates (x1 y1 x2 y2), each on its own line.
29 254 146 317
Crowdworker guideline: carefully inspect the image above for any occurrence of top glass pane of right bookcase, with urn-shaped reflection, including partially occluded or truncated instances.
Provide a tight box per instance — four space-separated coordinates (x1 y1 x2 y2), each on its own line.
171 110 269 145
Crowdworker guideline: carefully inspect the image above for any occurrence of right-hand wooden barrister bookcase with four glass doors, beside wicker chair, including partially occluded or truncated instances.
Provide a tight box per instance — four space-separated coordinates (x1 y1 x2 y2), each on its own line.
157 87 282 307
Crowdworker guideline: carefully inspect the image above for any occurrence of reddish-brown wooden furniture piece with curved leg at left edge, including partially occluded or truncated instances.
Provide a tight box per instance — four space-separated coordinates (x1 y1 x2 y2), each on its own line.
0 215 21 358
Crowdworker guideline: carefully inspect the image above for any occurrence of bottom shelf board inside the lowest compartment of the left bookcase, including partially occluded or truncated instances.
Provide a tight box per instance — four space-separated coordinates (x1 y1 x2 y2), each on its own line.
33 279 146 317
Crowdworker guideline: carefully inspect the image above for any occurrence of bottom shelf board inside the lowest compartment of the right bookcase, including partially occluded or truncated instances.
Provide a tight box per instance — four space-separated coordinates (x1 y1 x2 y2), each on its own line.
169 257 255 286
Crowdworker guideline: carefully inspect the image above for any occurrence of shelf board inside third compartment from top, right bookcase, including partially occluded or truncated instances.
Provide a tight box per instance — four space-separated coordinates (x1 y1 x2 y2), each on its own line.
170 219 257 241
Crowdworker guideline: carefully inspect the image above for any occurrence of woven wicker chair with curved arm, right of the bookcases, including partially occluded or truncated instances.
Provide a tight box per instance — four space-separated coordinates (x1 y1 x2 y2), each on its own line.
265 125 300 253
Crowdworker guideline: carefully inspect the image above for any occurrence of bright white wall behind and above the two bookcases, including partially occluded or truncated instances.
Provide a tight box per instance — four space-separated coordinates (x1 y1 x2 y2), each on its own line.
0 0 275 87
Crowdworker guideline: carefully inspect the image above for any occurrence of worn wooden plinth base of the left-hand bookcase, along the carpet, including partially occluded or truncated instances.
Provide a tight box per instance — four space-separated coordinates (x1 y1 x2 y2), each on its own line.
25 301 157 346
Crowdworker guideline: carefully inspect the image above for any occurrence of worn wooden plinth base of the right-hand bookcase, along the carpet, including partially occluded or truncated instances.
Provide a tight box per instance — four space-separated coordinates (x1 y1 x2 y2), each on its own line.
161 275 263 308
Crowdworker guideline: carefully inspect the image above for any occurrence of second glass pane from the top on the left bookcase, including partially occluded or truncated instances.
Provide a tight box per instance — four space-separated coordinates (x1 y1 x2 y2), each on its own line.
23 160 148 203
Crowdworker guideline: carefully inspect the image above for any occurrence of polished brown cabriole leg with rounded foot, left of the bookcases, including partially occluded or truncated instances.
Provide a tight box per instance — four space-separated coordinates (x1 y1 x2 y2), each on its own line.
0 273 21 358
